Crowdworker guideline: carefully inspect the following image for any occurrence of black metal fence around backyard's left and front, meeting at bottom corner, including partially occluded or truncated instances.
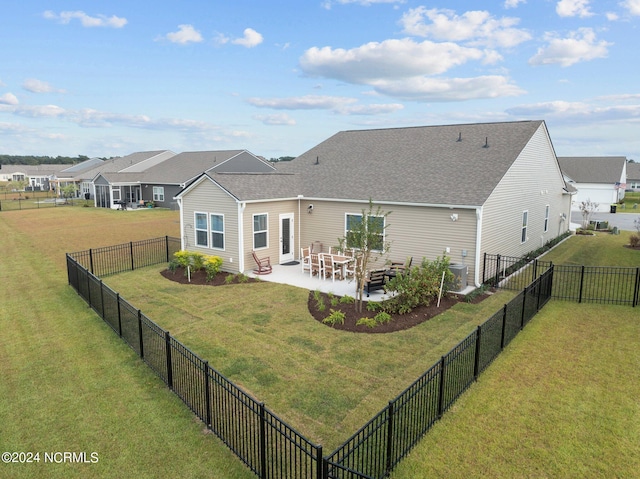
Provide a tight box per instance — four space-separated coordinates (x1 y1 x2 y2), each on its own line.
67 237 554 479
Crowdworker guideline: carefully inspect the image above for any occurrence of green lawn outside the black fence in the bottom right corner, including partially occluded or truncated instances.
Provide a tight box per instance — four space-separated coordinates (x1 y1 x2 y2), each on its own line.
391 301 640 479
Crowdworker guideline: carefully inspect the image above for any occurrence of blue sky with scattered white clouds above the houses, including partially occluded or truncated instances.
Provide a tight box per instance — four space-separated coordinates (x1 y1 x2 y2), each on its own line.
0 0 640 161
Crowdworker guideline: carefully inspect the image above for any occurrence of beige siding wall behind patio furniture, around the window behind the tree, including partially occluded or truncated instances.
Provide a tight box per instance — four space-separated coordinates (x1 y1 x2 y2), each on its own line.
300 200 476 280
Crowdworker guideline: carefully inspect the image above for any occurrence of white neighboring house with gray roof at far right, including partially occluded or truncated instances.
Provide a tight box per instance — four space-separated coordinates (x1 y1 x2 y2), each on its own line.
558 156 627 212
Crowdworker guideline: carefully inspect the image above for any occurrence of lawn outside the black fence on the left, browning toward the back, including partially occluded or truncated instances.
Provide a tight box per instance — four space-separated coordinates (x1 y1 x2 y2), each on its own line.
0 208 255 479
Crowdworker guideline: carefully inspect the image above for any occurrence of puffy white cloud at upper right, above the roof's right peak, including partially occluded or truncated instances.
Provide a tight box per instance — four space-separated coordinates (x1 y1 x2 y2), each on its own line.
529 28 612 67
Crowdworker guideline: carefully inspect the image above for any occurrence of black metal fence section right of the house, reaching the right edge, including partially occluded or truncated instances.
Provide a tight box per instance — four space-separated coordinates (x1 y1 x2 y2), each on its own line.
482 253 640 307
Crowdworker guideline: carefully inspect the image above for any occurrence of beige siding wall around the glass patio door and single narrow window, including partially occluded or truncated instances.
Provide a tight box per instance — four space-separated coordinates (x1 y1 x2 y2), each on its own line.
242 200 298 271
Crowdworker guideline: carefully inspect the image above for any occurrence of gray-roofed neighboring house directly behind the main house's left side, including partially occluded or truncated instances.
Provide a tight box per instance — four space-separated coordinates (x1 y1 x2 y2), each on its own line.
94 150 275 209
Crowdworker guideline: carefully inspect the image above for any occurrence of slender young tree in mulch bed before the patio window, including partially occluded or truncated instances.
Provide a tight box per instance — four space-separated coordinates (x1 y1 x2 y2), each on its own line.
338 199 391 313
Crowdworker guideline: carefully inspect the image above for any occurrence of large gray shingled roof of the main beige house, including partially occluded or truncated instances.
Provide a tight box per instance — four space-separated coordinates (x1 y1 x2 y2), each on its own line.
230 121 543 206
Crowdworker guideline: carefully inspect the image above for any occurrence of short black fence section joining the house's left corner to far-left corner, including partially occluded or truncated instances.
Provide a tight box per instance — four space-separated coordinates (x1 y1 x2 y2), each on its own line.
69 236 181 278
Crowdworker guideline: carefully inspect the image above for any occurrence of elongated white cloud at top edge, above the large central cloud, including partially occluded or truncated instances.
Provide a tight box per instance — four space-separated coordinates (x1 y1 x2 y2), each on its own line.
400 7 531 48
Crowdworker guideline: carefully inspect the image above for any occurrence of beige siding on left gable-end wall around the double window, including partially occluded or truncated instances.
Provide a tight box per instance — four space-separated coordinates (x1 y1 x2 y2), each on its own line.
182 180 238 273
